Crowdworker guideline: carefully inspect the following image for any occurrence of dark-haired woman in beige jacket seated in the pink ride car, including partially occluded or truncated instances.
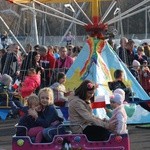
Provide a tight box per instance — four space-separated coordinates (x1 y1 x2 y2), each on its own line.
69 80 111 141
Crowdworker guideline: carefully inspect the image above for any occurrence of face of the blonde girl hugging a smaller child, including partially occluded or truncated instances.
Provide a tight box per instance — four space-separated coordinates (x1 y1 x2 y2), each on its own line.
40 92 51 107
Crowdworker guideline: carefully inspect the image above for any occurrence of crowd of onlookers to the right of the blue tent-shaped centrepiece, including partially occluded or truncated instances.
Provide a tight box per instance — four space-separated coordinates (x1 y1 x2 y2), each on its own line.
113 37 150 94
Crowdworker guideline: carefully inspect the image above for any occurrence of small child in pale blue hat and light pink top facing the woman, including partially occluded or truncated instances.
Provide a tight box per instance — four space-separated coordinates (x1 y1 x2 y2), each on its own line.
109 93 127 135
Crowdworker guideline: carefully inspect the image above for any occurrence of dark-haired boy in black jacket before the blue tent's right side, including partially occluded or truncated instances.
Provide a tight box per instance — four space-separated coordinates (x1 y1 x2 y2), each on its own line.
108 69 132 102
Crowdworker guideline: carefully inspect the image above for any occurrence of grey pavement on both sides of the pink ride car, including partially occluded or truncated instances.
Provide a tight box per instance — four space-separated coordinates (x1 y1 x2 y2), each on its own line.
0 119 150 150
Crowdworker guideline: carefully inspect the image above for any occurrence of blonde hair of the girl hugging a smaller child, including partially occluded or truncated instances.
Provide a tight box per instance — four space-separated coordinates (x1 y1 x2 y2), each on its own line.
38 87 54 105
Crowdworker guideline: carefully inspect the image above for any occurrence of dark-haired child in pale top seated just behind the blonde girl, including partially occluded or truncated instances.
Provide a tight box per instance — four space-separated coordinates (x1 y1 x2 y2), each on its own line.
50 72 70 105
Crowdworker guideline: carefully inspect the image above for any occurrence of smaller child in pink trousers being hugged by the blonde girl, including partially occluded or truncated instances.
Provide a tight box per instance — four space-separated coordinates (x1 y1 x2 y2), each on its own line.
17 94 43 143
